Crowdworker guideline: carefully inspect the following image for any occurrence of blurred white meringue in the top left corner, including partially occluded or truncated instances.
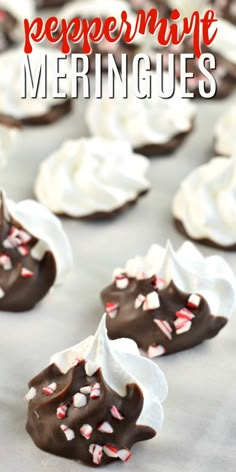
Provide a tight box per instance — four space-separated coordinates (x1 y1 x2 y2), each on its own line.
0 0 35 42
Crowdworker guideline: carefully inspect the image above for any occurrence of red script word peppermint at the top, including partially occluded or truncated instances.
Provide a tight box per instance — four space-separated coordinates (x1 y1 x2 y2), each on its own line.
24 8 218 58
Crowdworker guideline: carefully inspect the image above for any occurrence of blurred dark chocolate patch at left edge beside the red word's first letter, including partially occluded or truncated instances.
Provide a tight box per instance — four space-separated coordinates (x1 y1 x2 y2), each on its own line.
0 7 17 53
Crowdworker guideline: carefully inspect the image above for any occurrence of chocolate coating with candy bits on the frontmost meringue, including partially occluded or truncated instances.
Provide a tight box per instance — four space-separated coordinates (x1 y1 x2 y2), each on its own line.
26 361 156 465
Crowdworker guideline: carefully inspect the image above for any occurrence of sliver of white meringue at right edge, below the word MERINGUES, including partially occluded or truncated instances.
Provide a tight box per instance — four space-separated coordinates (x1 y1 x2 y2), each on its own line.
214 105 236 156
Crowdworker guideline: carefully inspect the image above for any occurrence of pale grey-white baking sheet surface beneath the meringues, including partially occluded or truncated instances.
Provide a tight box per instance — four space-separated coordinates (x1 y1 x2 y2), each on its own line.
0 56 236 472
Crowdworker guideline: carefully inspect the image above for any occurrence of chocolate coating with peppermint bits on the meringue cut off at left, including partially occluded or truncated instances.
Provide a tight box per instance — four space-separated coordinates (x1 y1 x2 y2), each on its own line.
0 195 56 312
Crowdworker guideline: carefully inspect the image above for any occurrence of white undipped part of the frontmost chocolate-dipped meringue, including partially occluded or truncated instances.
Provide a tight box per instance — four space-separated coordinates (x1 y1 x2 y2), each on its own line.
50 315 168 431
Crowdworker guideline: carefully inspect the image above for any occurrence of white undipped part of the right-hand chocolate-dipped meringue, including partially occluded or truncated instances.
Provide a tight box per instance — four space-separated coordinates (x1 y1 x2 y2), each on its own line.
114 241 236 318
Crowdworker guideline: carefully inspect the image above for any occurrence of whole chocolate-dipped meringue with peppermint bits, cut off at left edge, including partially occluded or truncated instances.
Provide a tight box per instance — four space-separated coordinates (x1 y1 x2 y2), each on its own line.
0 193 72 312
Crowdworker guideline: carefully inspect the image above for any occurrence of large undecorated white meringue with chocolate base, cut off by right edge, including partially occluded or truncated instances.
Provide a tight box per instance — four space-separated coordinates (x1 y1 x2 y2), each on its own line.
173 156 236 251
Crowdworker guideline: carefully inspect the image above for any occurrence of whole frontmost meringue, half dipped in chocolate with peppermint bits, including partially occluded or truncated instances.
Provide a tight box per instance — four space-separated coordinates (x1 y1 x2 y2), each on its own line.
25 316 167 465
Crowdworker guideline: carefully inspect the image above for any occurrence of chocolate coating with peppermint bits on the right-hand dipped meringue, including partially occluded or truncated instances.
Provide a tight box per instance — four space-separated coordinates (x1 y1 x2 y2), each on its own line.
102 276 227 355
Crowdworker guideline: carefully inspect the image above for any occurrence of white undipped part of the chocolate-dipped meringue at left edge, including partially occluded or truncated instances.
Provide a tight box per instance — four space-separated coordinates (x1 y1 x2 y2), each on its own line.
6 196 73 284
